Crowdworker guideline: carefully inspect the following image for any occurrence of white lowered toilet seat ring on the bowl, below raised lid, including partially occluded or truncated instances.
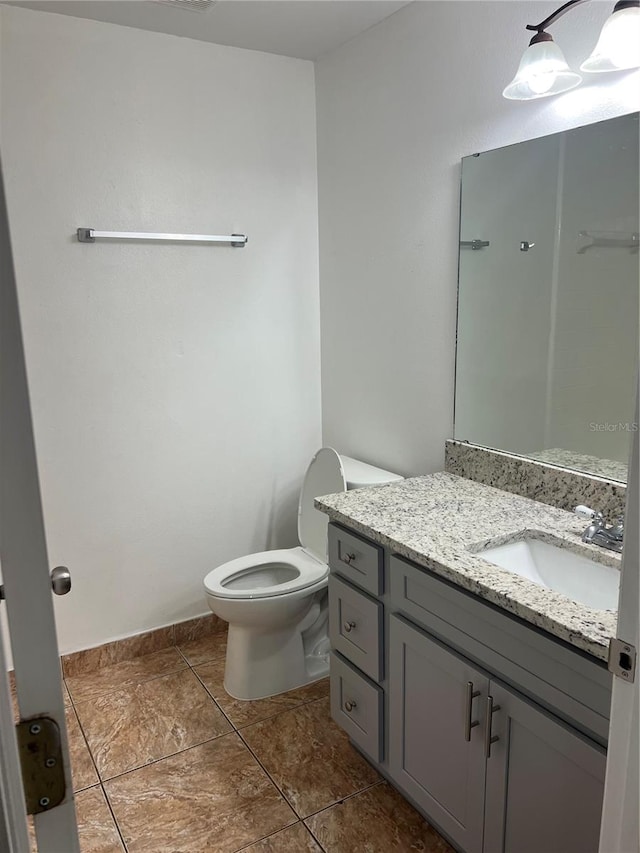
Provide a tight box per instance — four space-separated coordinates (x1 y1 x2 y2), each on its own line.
204 547 329 599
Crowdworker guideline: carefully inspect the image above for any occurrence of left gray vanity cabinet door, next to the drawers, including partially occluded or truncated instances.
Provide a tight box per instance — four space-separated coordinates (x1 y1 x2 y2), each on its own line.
389 616 488 853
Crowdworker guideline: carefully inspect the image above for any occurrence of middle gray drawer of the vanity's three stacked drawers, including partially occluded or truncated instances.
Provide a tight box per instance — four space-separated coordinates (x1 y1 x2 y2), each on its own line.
329 575 383 681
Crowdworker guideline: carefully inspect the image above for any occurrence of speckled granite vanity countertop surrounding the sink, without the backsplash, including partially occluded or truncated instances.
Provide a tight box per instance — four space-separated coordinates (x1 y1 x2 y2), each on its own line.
315 472 621 660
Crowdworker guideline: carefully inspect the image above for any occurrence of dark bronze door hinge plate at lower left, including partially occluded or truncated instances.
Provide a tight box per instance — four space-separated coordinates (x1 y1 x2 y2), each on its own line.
16 717 67 814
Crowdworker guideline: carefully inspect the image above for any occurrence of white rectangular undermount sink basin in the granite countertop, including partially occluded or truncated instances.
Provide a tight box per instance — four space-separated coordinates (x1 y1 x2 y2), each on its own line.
478 538 620 610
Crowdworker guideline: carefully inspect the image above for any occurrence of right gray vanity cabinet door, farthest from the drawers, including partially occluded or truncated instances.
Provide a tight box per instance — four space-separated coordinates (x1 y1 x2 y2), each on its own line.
484 681 606 853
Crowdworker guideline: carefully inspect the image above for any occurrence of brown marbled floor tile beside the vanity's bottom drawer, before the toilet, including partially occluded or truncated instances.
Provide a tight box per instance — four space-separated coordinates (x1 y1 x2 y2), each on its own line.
242 699 380 817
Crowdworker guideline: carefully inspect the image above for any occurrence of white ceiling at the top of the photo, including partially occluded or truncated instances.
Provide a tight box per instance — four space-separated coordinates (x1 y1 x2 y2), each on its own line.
10 0 410 59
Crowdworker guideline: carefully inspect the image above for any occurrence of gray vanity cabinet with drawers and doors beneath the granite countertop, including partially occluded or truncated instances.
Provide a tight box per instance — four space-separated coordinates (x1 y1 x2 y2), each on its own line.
329 524 611 853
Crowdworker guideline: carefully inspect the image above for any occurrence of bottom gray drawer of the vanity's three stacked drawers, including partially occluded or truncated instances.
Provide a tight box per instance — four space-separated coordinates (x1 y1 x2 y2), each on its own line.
331 652 383 761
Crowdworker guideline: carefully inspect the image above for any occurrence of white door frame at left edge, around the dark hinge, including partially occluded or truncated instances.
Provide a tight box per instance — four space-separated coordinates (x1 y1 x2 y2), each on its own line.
0 150 80 853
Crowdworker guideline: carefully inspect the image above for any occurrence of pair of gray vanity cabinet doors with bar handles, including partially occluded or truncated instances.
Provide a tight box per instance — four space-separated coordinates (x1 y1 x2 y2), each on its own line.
389 616 606 853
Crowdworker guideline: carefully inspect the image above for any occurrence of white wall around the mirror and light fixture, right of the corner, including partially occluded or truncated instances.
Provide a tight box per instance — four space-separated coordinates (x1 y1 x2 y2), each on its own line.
316 0 640 473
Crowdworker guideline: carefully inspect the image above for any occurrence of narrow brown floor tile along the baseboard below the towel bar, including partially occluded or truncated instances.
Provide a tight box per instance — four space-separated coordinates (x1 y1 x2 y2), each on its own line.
67 648 187 702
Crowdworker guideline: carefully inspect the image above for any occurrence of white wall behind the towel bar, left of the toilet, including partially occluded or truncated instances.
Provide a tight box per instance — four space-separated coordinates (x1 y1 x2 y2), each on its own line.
0 7 320 652
